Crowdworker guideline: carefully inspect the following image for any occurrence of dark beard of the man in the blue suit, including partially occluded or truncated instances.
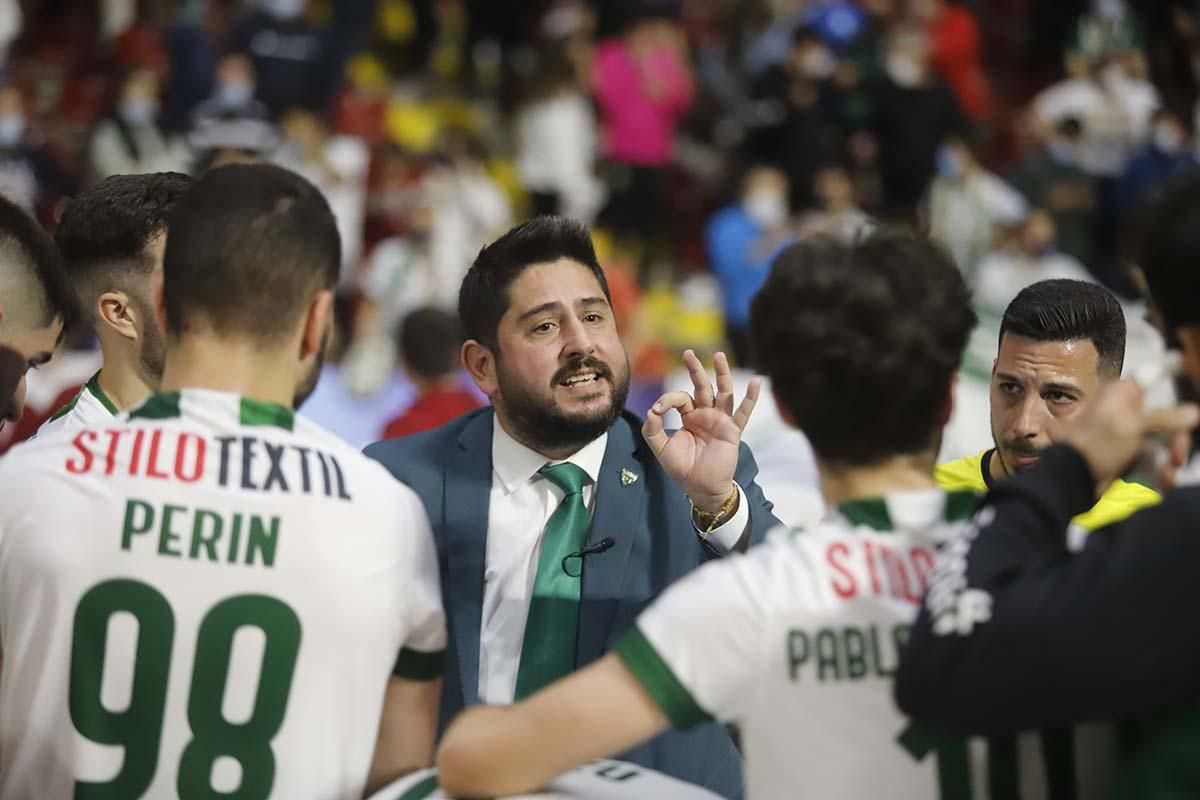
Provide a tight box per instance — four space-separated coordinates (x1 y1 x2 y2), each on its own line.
496 357 629 451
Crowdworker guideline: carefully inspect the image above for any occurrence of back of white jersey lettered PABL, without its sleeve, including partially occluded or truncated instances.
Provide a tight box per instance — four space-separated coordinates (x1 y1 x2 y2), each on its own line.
739 492 978 800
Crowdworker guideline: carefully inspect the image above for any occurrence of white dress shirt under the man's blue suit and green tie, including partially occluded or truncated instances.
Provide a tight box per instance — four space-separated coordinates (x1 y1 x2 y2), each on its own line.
479 420 750 705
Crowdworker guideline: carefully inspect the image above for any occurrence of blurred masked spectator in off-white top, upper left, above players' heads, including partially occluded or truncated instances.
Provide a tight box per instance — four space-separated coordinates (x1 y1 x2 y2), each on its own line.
91 70 191 181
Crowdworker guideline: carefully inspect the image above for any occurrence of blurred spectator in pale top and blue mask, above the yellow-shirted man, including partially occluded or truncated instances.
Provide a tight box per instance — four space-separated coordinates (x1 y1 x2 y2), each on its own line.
926 136 1028 283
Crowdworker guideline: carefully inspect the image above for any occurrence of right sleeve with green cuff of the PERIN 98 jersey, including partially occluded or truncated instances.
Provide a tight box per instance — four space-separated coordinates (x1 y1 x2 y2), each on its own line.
394 487 446 680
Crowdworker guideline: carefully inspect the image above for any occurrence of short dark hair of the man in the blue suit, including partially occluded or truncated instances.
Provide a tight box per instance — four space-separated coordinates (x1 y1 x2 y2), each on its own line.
458 215 612 350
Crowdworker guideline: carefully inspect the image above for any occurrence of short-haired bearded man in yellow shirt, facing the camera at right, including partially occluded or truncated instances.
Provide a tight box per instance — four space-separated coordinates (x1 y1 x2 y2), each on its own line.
935 278 1160 530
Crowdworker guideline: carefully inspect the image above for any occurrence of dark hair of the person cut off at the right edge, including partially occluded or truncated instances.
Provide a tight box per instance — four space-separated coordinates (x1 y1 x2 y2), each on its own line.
1139 172 1200 332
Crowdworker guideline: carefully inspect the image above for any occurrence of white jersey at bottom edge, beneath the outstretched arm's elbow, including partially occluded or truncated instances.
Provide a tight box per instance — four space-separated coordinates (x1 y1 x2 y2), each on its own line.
370 759 720 800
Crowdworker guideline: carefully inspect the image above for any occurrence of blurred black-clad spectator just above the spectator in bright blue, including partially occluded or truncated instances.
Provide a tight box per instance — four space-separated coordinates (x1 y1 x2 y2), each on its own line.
745 26 838 207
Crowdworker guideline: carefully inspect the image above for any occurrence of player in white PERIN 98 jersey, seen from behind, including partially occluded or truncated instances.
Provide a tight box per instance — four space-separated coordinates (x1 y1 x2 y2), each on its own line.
0 166 445 800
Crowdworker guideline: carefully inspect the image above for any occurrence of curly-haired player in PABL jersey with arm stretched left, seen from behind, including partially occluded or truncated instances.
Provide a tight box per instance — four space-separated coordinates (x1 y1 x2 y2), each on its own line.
438 230 976 800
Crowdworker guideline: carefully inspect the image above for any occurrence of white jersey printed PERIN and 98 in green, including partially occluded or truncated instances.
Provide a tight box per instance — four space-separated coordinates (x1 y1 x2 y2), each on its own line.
0 390 446 800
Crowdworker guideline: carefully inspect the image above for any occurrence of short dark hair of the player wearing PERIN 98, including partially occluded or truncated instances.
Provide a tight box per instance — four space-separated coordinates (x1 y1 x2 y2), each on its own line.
163 164 342 341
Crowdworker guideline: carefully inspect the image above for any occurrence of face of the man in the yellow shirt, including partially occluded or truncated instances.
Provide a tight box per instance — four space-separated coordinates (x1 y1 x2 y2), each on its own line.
991 333 1103 475
